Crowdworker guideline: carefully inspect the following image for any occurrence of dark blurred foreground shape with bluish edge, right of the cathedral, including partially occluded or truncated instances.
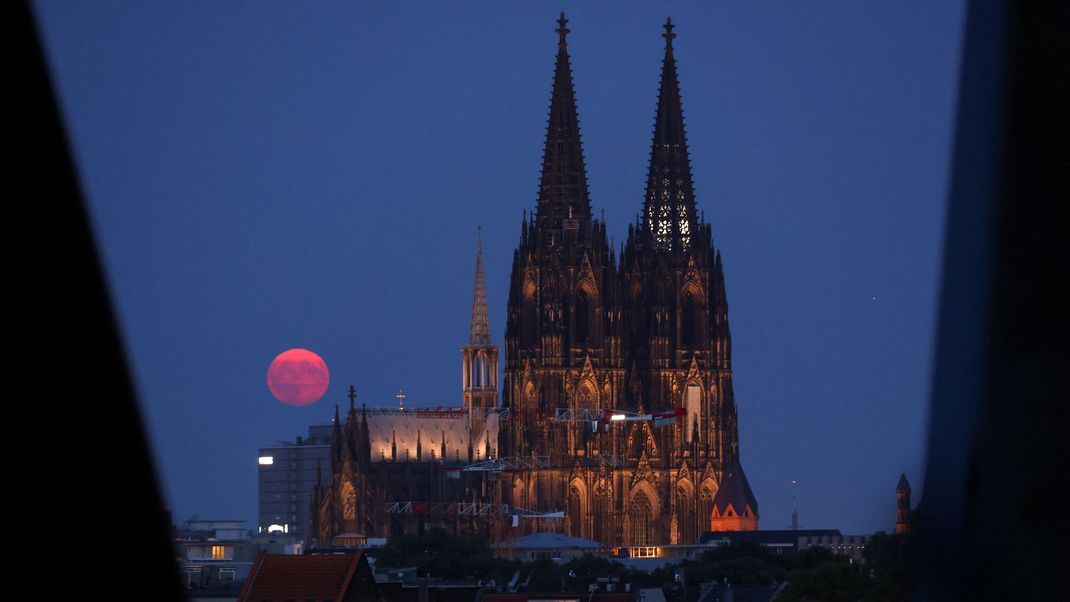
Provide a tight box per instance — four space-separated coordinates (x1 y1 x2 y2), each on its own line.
917 0 1070 600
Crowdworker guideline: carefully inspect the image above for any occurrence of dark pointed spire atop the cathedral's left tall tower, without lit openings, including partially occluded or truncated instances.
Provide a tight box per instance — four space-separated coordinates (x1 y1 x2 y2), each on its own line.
535 13 591 230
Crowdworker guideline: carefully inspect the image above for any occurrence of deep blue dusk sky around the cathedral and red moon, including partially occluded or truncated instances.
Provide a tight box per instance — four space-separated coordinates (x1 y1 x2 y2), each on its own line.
36 1 962 534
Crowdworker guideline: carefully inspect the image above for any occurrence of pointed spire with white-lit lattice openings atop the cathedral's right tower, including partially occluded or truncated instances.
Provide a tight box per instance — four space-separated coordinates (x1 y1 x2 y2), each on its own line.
643 18 697 249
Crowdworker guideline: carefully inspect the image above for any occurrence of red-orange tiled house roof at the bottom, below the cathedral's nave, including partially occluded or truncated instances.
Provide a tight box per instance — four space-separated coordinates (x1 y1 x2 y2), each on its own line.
238 552 362 602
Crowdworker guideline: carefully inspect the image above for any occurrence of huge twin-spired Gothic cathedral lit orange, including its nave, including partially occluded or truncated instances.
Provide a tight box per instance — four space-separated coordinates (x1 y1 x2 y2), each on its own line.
309 15 758 546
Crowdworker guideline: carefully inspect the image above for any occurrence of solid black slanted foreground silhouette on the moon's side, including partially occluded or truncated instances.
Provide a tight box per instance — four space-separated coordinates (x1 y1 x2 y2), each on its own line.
18 2 184 600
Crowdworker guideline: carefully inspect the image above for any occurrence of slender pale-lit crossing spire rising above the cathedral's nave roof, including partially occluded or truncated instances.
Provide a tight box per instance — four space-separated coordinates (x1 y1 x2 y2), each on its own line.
461 230 498 460
